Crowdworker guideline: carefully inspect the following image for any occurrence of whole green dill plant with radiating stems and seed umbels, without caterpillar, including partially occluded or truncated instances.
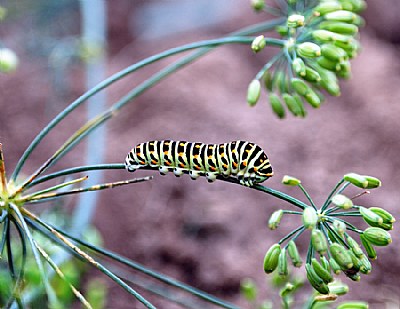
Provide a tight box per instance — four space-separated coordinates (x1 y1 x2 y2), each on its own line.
0 0 395 308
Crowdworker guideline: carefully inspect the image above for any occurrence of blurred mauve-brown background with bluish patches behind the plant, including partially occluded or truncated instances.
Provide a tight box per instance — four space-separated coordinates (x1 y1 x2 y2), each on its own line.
0 0 400 308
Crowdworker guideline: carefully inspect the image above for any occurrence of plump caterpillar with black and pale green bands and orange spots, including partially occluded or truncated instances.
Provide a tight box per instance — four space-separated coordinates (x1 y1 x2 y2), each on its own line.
125 140 274 186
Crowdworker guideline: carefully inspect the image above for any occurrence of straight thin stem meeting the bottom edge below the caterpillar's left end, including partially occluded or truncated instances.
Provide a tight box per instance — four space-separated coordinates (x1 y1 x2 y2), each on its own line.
21 208 155 309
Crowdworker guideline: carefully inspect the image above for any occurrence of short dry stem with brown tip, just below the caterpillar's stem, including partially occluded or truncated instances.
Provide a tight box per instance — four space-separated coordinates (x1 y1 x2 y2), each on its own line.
16 176 153 203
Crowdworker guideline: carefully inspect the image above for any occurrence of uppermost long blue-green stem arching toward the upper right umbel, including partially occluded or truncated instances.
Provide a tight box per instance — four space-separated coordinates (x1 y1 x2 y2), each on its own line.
11 19 284 182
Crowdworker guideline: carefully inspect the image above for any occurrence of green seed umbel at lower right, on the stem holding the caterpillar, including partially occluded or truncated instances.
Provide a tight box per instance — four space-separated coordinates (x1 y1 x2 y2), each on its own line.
264 173 396 294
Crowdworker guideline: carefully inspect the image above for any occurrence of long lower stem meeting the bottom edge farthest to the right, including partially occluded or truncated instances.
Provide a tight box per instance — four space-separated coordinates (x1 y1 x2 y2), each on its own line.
26 216 237 309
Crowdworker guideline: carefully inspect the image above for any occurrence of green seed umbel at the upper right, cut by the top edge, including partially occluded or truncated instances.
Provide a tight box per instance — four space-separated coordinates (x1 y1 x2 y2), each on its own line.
247 0 366 118
